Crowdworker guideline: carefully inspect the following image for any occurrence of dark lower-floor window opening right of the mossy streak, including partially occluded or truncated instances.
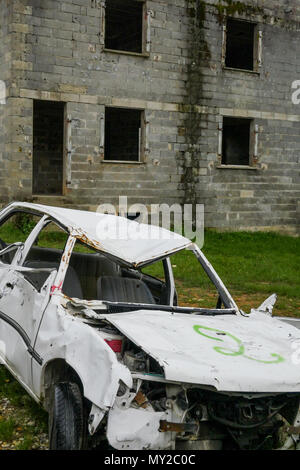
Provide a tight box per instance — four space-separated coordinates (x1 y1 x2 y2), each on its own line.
222 117 251 165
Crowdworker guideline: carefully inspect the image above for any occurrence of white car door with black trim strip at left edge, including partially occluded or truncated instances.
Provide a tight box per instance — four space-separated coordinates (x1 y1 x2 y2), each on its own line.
0 209 50 388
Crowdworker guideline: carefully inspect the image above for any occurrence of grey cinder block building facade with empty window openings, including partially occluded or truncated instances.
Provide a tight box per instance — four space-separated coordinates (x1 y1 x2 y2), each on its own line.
0 0 300 232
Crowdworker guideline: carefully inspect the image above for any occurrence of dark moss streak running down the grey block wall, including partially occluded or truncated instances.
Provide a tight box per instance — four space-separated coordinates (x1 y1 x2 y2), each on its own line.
178 0 263 209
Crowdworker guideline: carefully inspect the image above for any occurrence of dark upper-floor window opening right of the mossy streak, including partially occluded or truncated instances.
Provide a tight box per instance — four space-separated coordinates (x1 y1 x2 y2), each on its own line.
225 19 256 70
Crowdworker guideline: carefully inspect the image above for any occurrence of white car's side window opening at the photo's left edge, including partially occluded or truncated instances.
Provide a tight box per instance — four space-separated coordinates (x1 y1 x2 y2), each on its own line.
0 211 41 264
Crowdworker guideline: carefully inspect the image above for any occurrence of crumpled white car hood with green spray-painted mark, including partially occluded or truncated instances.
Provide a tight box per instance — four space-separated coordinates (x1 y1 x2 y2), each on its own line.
101 310 300 393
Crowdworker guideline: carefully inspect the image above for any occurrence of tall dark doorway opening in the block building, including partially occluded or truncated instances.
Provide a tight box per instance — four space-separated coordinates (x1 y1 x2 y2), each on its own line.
32 101 64 195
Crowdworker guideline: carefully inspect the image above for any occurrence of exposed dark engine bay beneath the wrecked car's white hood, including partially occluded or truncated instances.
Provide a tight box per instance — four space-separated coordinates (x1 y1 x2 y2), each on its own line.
91 321 300 450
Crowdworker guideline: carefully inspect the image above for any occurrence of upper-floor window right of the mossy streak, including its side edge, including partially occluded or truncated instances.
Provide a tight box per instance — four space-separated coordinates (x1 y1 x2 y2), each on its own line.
223 18 261 71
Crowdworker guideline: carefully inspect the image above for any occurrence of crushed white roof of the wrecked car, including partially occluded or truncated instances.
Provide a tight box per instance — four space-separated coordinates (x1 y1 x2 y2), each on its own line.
7 202 192 266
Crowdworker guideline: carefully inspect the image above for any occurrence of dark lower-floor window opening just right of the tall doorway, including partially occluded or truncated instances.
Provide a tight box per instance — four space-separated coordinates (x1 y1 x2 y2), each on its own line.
104 108 142 162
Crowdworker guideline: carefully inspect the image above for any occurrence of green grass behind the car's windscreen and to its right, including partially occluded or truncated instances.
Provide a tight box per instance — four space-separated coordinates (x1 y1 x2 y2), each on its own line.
145 231 300 316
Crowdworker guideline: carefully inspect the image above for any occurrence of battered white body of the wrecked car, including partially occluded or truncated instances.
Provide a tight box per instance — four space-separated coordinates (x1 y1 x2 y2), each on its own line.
0 202 300 450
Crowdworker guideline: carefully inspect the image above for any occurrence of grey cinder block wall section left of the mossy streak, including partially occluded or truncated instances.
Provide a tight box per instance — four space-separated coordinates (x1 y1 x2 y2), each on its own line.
4 0 188 208
